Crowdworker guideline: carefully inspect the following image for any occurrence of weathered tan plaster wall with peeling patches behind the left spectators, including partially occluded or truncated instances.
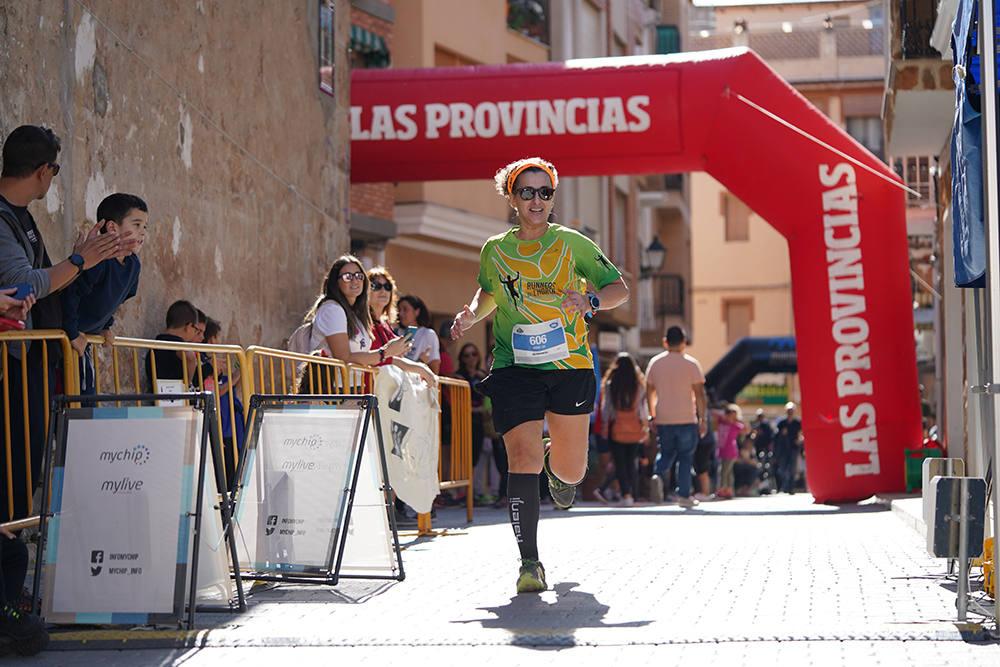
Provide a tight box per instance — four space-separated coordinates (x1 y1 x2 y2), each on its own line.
0 0 350 346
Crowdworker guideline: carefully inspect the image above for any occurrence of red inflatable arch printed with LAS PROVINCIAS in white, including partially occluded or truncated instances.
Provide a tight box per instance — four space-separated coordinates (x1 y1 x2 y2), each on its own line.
351 49 921 502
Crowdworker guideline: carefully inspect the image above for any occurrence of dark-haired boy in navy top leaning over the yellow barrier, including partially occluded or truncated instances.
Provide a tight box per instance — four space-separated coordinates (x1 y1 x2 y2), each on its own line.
61 192 149 394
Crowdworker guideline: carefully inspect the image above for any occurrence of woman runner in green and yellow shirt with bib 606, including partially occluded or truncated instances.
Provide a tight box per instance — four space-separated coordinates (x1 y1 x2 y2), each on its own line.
452 157 628 593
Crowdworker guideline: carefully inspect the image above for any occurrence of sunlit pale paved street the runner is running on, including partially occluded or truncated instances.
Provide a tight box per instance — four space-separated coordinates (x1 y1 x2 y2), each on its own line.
36 494 1000 665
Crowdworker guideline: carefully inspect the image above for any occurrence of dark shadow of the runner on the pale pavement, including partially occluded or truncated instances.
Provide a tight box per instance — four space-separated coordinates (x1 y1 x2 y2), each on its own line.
453 581 652 649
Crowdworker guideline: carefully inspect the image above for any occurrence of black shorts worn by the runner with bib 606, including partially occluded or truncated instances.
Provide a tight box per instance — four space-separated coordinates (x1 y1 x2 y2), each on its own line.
479 366 597 433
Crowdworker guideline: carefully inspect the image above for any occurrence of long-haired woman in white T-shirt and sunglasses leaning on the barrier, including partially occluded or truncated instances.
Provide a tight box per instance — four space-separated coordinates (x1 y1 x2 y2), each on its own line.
306 255 437 387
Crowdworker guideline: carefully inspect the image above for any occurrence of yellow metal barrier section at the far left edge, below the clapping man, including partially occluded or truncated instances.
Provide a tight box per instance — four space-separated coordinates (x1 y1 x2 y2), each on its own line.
0 329 79 520
